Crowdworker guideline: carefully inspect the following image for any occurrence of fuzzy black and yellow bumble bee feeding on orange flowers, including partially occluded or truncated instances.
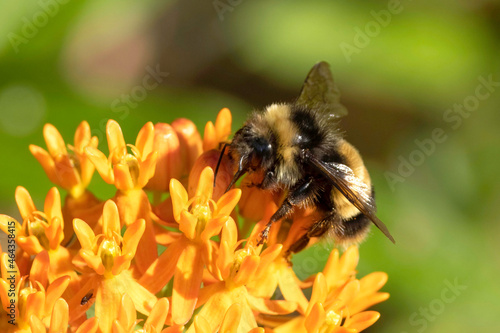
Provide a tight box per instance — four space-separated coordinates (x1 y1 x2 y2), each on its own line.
216 62 394 253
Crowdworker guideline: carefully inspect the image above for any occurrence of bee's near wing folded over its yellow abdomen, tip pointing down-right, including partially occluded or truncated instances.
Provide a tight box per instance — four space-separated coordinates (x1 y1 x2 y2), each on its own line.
307 154 396 243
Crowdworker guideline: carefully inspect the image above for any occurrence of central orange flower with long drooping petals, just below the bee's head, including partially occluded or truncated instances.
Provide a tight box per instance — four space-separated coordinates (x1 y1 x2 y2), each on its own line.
139 167 241 325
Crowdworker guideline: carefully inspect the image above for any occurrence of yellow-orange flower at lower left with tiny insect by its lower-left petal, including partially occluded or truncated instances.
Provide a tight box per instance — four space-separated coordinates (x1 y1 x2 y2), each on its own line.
72 200 156 332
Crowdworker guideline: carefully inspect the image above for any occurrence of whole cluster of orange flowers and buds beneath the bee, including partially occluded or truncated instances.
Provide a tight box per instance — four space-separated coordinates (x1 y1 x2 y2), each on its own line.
0 109 389 333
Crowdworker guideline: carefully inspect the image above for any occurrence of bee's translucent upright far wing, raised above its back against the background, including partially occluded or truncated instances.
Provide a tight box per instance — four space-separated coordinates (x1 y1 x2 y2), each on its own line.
296 61 347 118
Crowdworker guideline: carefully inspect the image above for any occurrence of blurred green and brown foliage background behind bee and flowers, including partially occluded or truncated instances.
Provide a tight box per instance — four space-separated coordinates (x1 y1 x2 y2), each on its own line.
0 0 500 332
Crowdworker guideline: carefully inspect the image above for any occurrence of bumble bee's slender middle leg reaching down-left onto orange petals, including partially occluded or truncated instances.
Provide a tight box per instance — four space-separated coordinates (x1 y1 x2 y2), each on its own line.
258 177 314 245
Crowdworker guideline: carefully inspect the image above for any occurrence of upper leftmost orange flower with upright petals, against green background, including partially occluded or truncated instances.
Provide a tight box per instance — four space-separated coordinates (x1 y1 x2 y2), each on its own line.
30 121 98 198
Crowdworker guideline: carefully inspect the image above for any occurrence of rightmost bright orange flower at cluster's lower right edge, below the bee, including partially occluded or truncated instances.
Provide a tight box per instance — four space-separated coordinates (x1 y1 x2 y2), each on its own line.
266 246 389 333
